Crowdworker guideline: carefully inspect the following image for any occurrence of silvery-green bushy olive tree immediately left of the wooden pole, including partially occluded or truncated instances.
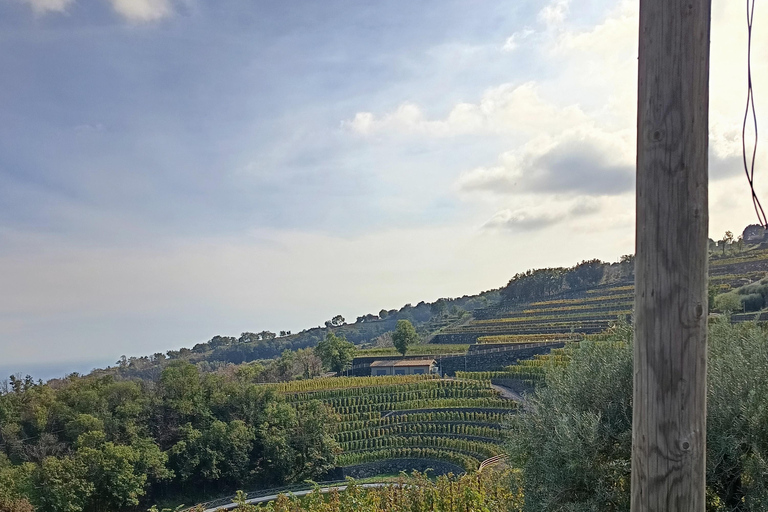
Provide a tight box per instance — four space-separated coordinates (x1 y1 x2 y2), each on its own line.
506 326 632 512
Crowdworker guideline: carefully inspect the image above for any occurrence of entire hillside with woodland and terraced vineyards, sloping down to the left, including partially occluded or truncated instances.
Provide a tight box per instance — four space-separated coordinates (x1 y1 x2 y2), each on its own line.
0 228 768 512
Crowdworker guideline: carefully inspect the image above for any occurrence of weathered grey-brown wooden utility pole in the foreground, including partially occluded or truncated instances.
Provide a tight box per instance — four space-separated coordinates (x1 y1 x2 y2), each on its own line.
632 0 711 512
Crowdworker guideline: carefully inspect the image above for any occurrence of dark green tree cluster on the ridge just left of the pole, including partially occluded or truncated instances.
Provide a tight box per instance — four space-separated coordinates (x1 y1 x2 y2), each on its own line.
501 259 608 301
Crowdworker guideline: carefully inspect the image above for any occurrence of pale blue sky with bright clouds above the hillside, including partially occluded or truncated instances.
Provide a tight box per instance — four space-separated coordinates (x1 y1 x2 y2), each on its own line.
0 0 768 378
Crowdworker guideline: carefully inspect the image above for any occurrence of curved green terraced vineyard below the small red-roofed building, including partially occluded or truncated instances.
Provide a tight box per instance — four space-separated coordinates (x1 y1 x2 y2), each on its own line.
274 376 517 470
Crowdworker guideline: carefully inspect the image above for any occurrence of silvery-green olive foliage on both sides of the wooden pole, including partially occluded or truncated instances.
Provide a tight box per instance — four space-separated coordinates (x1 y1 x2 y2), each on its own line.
506 321 768 512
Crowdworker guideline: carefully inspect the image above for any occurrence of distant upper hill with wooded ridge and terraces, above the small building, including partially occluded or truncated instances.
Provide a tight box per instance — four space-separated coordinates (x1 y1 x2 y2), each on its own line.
43 226 768 379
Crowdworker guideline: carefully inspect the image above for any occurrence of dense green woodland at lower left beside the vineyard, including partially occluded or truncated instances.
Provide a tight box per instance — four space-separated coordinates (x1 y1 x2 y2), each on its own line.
0 360 338 512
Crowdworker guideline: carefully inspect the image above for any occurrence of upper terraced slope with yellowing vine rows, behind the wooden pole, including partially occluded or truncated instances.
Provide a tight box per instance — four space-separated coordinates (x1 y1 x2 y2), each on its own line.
432 241 768 344
